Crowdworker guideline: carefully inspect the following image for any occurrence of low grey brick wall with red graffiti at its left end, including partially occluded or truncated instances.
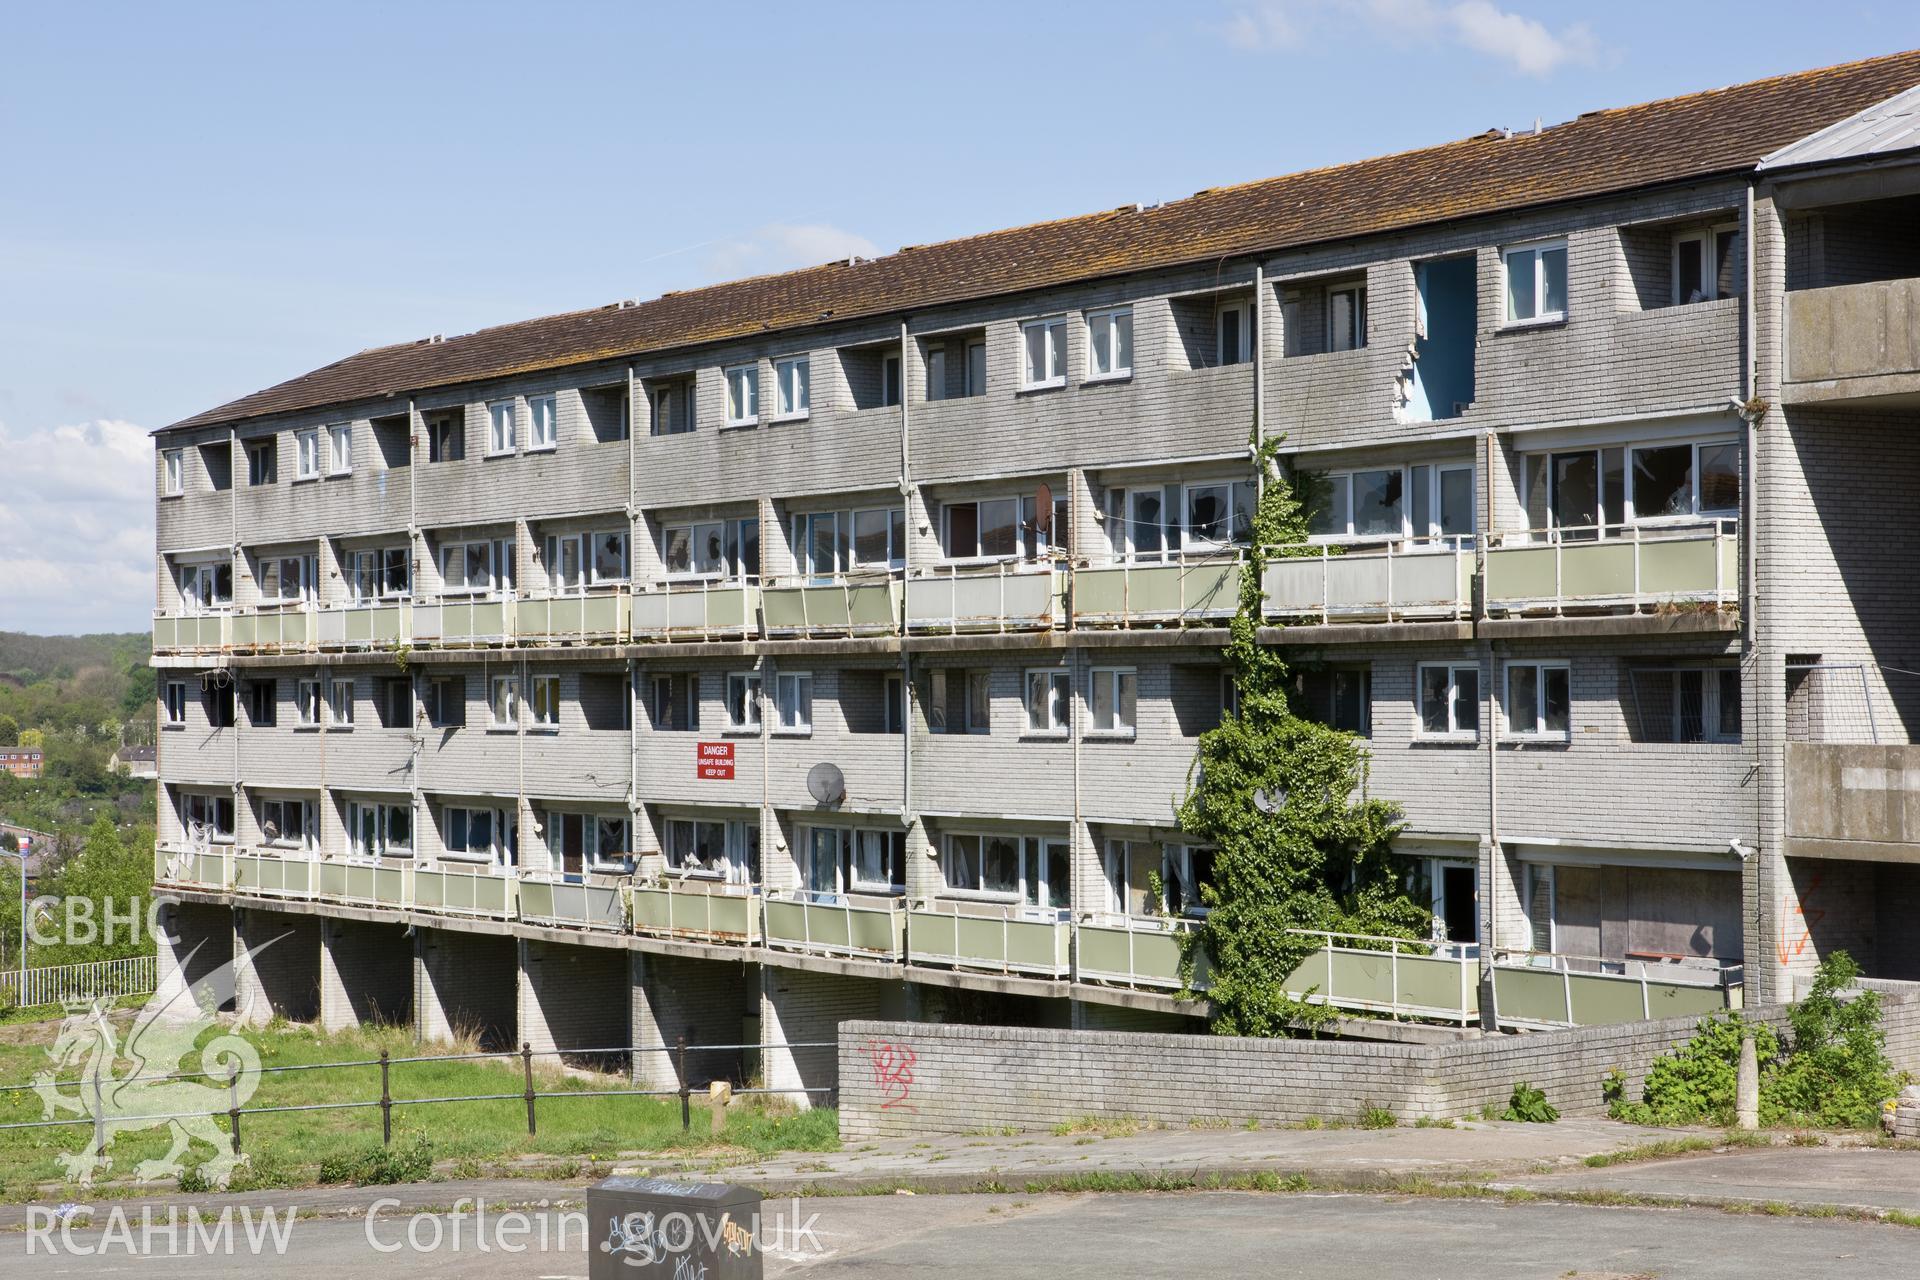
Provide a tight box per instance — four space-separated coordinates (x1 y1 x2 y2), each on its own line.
839 994 1920 1142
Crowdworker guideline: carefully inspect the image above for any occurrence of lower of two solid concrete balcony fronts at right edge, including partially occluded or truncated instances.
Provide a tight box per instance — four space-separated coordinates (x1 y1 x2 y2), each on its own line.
1786 743 1920 862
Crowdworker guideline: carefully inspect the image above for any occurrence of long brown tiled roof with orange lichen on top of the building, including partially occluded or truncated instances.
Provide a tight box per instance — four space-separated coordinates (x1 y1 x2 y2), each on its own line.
167 52 1920 430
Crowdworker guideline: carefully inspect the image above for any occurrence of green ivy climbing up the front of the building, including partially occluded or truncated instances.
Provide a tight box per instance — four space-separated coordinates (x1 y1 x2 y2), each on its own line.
1179 439 1430 1036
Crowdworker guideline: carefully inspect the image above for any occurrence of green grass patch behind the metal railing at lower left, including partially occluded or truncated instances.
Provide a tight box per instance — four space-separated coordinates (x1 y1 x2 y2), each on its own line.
0 1019 839 1199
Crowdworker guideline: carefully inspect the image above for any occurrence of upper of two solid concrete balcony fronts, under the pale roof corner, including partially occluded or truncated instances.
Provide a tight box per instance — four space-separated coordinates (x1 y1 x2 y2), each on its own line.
1782 280 1920 405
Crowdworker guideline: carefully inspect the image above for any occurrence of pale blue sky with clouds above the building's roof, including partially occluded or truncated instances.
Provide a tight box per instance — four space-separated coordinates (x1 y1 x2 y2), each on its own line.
0 0 1920 633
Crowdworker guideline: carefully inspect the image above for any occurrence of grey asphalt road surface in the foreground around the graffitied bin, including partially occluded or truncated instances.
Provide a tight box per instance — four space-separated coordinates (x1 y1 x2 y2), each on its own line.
0 1192 1920 1280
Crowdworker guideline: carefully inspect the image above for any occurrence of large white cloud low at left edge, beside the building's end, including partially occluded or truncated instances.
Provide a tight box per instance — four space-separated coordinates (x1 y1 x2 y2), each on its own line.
0 418 154 633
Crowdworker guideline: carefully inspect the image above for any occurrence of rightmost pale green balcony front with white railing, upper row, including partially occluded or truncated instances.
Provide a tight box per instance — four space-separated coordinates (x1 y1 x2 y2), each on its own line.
1486 520 1740 614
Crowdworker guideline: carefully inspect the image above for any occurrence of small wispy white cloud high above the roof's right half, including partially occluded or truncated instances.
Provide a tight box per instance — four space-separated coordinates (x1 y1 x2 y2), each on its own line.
1219 0 1599 77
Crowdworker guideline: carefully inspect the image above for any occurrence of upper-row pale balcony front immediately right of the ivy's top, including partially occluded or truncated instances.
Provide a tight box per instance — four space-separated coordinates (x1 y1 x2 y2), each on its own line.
1260 537 1475 624
